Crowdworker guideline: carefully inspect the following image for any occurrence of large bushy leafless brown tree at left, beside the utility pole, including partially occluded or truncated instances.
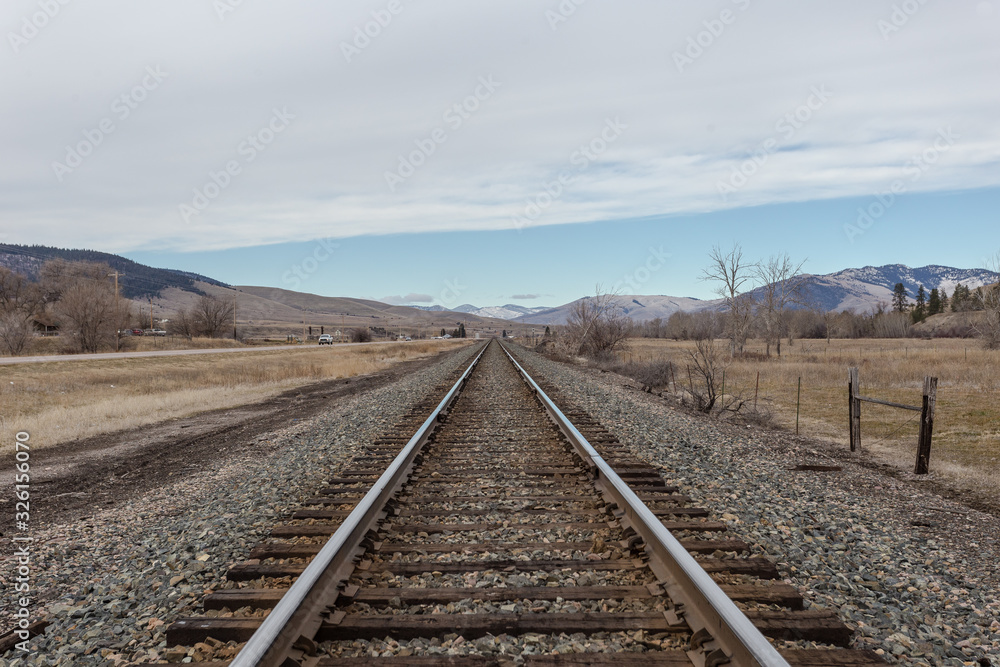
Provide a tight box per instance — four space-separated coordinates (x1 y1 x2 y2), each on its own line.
41 260 120 352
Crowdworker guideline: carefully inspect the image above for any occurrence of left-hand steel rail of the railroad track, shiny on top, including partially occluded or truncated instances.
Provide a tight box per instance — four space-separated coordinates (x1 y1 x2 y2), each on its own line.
230 342 489 667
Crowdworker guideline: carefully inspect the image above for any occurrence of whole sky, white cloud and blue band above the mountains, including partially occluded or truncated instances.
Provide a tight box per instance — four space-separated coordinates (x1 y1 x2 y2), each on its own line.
0 0 1000 306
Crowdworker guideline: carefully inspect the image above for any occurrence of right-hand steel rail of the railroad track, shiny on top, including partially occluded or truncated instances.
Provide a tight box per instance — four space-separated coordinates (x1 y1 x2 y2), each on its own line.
500 344 788 667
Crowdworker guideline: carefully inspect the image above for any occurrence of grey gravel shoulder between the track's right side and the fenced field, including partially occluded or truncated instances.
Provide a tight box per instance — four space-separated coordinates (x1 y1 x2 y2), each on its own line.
519 351 1000 666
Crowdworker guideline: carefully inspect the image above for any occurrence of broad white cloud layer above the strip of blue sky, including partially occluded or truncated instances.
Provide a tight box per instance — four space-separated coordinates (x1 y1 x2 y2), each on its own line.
0 0 1000 251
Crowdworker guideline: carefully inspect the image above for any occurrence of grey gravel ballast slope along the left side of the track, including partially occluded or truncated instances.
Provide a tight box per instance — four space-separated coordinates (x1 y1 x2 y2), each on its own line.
0 347 484 667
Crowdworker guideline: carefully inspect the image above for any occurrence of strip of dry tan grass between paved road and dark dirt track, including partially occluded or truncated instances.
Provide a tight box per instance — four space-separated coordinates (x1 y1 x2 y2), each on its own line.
0 341 462 452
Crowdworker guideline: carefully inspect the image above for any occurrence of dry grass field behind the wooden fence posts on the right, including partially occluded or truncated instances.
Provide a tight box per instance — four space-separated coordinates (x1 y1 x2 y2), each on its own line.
625 339 1000 498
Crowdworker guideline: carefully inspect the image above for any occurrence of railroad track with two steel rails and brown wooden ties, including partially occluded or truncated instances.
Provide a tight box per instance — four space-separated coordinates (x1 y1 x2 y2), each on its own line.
154 341 882 667
